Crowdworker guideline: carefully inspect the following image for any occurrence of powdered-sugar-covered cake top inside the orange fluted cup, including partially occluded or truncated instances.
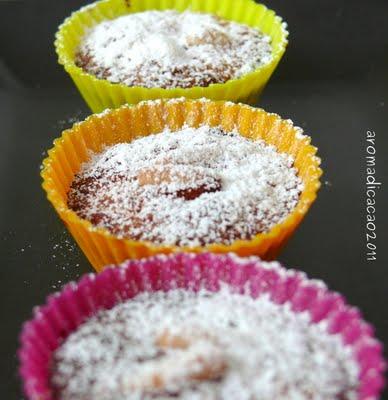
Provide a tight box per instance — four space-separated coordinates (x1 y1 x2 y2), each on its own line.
68 125 303 246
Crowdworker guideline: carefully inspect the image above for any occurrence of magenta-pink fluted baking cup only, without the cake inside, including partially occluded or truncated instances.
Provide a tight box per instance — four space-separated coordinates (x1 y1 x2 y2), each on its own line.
18 253 386 400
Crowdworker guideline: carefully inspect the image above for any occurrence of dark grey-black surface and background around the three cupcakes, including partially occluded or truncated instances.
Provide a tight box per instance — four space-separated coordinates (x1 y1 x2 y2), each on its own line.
0 0 388 400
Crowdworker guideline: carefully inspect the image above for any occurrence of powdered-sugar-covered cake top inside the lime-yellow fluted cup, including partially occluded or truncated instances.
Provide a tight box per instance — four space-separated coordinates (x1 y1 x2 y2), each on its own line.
75 10 272 88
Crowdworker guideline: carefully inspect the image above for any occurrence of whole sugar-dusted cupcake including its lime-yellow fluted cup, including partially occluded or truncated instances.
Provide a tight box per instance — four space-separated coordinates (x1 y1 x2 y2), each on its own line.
55 0 287 112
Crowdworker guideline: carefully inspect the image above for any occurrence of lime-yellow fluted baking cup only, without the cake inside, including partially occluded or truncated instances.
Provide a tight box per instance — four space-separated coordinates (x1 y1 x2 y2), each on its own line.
55 0 288 112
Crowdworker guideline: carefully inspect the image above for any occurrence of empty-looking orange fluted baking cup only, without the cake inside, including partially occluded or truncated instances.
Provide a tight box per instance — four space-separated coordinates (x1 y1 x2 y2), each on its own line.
41 99 322 271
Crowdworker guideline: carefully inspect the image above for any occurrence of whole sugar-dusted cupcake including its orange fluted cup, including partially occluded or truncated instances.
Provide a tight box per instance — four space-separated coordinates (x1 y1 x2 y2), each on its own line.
42 99 321 270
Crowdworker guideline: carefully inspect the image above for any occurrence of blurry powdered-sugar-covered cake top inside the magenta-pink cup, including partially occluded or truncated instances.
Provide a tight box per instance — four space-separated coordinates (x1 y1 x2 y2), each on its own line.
51 286 359 400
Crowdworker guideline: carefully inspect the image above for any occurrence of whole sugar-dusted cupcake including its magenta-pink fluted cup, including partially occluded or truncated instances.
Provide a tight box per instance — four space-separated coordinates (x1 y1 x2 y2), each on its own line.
19 254 385 400
